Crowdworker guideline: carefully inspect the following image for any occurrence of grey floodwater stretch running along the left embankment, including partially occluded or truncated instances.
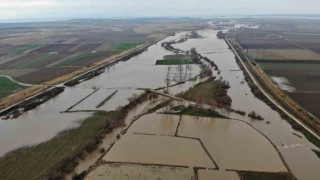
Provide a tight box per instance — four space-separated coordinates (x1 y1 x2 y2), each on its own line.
0 33 200 156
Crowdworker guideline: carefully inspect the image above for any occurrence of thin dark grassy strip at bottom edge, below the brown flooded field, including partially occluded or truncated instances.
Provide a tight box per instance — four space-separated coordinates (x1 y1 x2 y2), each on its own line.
238 171 294 180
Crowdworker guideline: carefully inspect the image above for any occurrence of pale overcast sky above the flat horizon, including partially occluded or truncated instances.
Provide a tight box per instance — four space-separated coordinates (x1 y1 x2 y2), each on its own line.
0 0 320 21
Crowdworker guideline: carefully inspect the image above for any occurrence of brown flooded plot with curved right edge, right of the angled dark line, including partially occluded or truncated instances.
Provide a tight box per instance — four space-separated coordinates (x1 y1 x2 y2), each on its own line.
178 116 287 172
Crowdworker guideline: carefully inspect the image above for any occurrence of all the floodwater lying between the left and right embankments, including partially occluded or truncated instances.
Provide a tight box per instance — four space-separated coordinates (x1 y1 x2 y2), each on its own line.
0 27 320 180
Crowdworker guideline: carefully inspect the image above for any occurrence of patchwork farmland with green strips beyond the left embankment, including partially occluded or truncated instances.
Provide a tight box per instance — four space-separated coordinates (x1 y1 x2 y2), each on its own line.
0 18 206 99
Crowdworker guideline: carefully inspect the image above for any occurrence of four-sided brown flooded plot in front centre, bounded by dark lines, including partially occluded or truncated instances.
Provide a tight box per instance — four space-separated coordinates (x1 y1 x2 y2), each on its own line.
103 134 215 168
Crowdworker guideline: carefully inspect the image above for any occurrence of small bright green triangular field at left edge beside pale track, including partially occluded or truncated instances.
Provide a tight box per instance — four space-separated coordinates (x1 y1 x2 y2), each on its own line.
0 76 27 99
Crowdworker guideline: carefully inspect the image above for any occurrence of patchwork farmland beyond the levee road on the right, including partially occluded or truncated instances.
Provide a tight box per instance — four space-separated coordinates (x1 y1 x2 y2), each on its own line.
236 20 320 117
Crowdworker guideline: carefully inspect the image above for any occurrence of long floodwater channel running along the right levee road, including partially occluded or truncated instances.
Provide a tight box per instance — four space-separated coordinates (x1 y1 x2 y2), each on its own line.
174 30 320 180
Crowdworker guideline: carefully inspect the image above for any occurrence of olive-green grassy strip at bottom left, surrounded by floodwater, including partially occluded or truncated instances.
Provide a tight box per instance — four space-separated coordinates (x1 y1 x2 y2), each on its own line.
0 112 119 180
